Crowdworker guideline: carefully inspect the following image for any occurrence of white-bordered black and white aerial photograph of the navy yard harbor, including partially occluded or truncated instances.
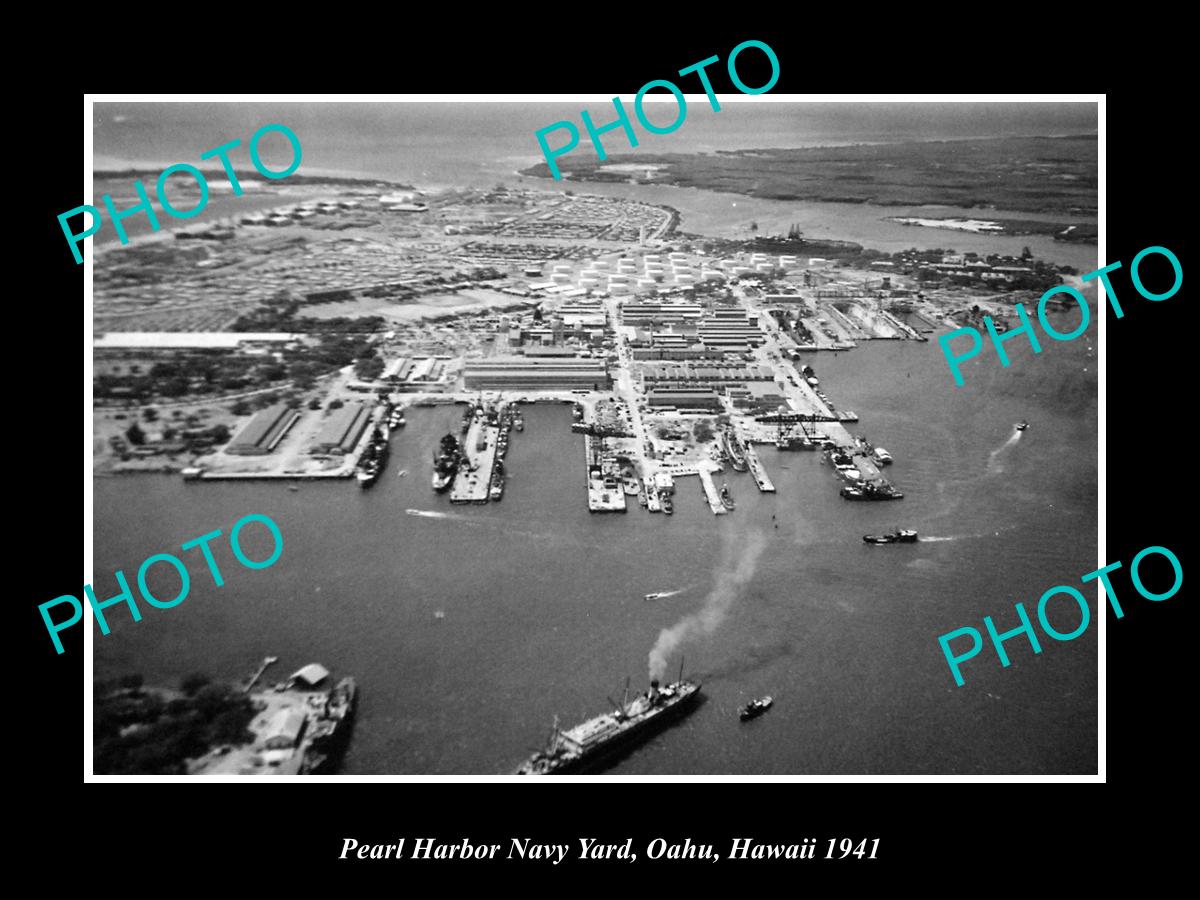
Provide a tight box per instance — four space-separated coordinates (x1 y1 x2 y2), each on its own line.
75 95 1104 780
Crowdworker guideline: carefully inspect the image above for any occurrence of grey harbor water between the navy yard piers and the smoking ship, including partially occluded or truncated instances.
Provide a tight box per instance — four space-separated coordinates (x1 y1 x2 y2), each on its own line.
94 324 1097 774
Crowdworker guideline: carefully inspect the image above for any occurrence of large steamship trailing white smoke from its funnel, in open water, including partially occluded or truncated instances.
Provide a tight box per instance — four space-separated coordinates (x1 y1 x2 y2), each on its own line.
516 666 700 775
